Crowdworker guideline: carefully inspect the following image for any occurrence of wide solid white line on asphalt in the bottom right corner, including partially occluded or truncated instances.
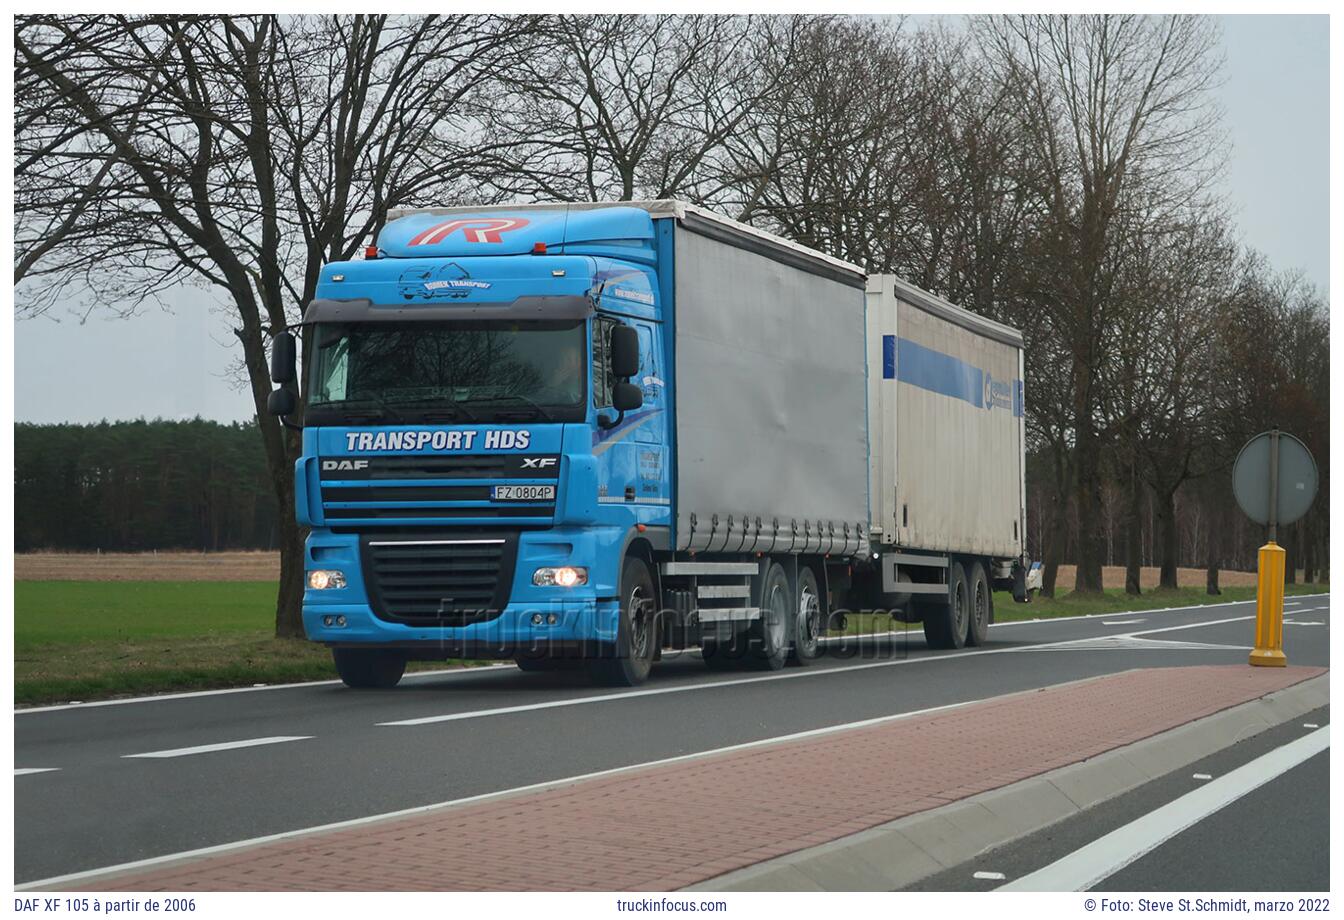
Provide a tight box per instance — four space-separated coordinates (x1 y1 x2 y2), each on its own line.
999 727 1331 892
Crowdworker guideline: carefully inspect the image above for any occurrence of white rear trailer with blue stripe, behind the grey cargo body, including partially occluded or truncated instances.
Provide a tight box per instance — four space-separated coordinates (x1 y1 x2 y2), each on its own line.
851 275 1027 647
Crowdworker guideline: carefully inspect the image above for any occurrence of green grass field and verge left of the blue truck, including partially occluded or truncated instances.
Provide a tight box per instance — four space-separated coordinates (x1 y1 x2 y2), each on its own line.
13 582 486 704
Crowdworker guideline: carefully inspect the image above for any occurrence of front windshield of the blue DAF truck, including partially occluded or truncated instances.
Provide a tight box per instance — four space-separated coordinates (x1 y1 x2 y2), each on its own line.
306 320 586 424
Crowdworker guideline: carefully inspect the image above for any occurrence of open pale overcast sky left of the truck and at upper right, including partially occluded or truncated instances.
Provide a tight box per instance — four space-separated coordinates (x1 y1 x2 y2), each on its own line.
15 16 1329 422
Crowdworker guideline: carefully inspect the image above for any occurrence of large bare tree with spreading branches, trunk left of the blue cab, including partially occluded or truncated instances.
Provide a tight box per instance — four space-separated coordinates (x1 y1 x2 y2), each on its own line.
15 15 531 635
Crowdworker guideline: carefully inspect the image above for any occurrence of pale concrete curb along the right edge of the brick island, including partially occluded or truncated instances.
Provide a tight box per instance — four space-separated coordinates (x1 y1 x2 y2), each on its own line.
683 673 1331 892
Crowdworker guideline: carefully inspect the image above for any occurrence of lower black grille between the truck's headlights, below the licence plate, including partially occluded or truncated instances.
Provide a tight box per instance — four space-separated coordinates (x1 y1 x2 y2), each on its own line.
360 531 517 626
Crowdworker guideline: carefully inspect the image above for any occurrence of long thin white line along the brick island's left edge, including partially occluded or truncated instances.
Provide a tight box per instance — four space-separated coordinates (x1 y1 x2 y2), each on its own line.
15 693 999 890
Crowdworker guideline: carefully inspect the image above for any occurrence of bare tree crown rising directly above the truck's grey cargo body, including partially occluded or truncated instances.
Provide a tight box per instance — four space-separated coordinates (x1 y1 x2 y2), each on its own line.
482 15 789 201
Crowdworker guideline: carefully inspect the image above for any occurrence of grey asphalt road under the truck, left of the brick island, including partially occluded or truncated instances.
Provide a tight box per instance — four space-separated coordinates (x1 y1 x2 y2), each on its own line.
15 596 1329 884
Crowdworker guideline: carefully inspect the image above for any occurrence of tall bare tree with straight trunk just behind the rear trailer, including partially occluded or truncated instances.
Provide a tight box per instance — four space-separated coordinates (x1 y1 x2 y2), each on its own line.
977 15 1218 591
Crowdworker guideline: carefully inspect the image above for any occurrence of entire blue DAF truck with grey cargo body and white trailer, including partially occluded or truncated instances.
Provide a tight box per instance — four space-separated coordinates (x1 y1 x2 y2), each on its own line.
270 200 1031 688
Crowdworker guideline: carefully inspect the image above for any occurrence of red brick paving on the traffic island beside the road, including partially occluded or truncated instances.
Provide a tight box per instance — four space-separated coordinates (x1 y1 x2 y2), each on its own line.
68 666 1324 890
